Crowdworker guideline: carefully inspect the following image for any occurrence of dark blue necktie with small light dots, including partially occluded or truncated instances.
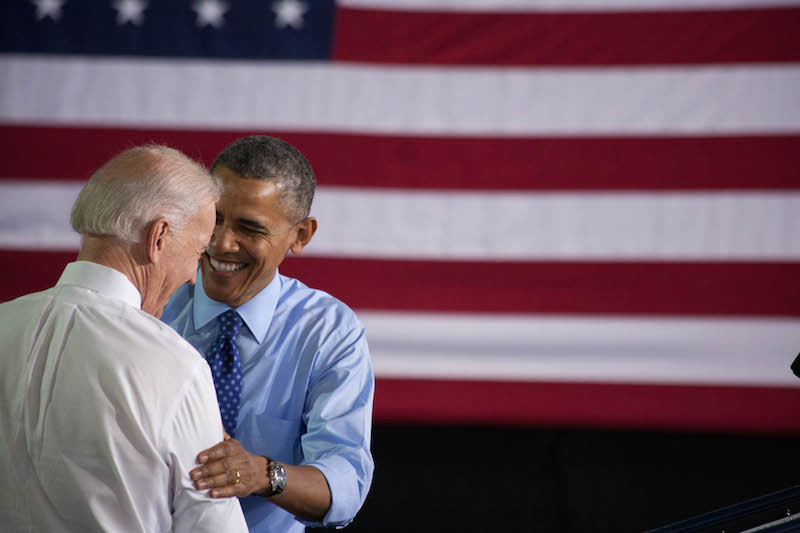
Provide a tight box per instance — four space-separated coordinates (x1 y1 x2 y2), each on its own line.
208 309 242 437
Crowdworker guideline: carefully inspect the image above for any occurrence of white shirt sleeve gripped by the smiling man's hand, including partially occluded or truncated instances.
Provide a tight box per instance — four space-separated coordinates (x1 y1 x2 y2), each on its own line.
162 360 247 533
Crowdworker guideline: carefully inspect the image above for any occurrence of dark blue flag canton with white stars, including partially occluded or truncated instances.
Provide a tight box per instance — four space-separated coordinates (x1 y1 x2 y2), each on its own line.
0 0 334 60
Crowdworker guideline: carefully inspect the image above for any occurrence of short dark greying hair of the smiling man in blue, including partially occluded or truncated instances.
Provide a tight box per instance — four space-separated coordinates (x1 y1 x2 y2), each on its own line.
211 135 317 222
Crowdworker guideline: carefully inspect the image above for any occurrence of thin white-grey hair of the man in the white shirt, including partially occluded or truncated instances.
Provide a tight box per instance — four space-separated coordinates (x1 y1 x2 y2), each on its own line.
70 144 222 244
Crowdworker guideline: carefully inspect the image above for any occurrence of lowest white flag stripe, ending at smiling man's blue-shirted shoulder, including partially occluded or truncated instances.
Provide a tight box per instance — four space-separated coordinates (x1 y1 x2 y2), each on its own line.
358 311 800 387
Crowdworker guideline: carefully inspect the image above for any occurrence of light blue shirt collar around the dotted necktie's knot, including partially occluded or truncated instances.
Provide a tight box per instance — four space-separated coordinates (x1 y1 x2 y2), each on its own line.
193 269 281 344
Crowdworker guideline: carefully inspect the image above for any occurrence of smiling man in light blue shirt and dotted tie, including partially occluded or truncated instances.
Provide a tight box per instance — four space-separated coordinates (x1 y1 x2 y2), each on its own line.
163 136 374 532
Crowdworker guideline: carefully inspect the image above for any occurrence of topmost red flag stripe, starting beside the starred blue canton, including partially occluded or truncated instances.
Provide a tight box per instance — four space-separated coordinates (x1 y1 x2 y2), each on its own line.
333 8 800 66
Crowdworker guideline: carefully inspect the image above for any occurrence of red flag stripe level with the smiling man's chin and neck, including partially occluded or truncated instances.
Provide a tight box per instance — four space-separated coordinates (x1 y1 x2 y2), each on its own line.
0 251 800 316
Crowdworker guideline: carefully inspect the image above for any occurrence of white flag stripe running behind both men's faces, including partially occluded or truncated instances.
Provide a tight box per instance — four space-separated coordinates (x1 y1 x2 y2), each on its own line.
0 181 800 261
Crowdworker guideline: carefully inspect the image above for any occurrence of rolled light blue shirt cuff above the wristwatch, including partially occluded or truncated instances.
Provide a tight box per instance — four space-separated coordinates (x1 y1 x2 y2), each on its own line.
303 455 361 528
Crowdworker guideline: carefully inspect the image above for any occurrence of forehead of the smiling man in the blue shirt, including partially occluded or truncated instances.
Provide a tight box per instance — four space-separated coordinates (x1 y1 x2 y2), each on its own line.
214 166 286 220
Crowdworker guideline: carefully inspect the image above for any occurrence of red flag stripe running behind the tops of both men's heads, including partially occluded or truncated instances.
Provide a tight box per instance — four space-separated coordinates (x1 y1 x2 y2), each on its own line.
0 125 800 190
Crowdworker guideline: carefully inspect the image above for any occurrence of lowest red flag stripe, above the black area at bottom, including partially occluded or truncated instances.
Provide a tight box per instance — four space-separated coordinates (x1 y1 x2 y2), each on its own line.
374 378 800 434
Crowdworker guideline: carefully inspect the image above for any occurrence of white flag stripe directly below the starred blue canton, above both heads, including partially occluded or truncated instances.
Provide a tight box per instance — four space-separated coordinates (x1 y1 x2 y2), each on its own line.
0 55 800 136
